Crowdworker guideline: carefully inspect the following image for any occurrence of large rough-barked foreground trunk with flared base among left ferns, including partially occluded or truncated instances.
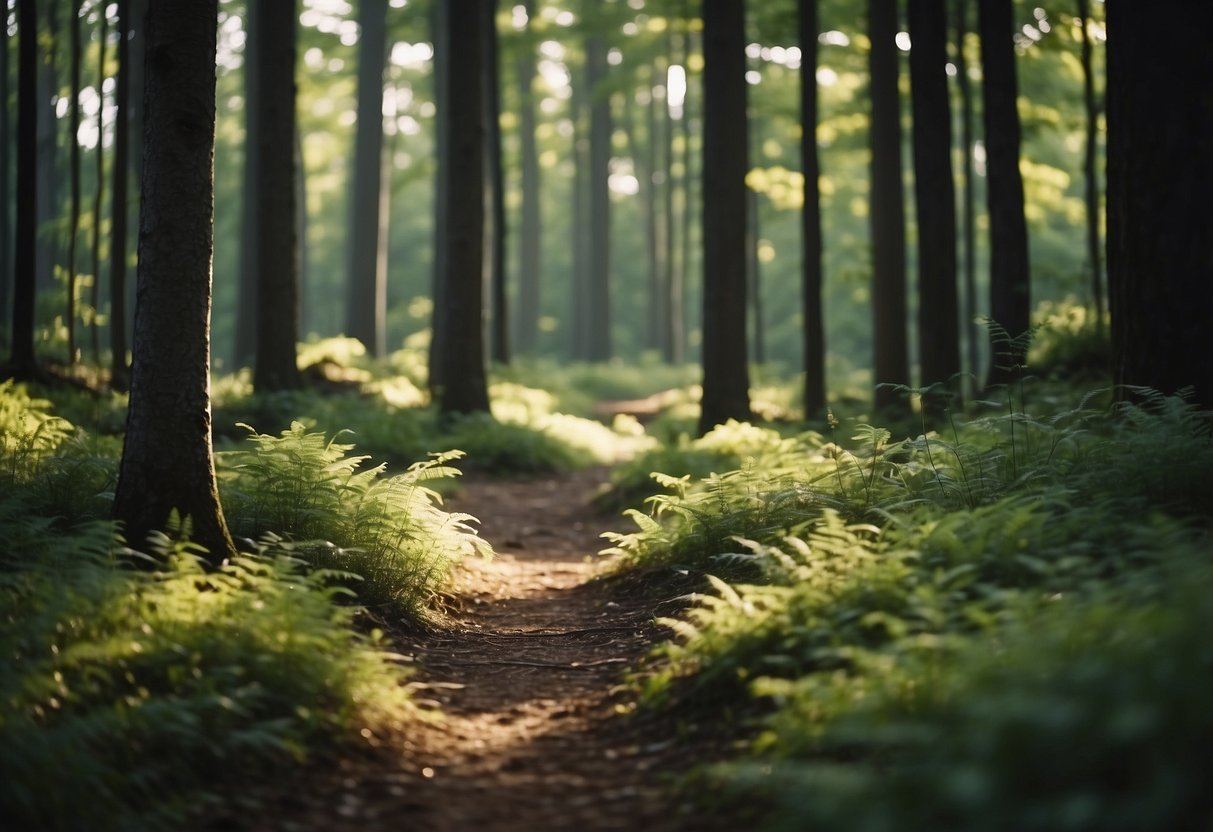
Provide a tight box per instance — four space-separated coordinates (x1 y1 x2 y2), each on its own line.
114 0 235 559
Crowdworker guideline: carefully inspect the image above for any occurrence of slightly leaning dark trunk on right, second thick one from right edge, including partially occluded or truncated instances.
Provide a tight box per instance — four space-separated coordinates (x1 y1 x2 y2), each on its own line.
978 0 1031 386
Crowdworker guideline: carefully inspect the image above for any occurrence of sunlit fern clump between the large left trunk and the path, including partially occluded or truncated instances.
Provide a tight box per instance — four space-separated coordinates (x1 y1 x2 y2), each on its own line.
217 422 491 616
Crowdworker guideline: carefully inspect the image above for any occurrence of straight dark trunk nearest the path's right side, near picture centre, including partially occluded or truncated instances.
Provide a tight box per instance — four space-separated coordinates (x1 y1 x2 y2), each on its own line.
699 0 752 433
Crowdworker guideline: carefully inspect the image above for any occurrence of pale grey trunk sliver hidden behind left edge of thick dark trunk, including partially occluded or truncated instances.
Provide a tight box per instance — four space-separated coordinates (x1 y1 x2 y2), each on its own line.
427 4 452 390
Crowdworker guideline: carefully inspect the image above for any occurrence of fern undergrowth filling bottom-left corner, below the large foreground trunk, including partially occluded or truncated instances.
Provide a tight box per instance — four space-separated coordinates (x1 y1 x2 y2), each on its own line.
0 511 412 831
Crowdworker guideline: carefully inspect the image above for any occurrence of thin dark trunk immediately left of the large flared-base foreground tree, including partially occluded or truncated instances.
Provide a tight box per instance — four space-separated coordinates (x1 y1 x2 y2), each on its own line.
109 0 131 392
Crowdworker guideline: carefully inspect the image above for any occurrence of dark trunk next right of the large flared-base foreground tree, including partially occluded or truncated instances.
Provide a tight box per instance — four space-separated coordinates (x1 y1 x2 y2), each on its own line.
251 0 299 392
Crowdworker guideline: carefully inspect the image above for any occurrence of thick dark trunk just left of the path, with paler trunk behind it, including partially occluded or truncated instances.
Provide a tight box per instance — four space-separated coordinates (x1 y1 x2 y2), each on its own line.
437 0 489 417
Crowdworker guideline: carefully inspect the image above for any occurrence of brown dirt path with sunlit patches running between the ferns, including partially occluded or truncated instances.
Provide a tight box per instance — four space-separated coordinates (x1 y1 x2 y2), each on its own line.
226 469 736 832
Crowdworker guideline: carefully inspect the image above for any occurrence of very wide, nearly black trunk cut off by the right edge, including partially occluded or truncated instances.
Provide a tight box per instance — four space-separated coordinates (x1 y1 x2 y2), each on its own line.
1106 0 1213 409
